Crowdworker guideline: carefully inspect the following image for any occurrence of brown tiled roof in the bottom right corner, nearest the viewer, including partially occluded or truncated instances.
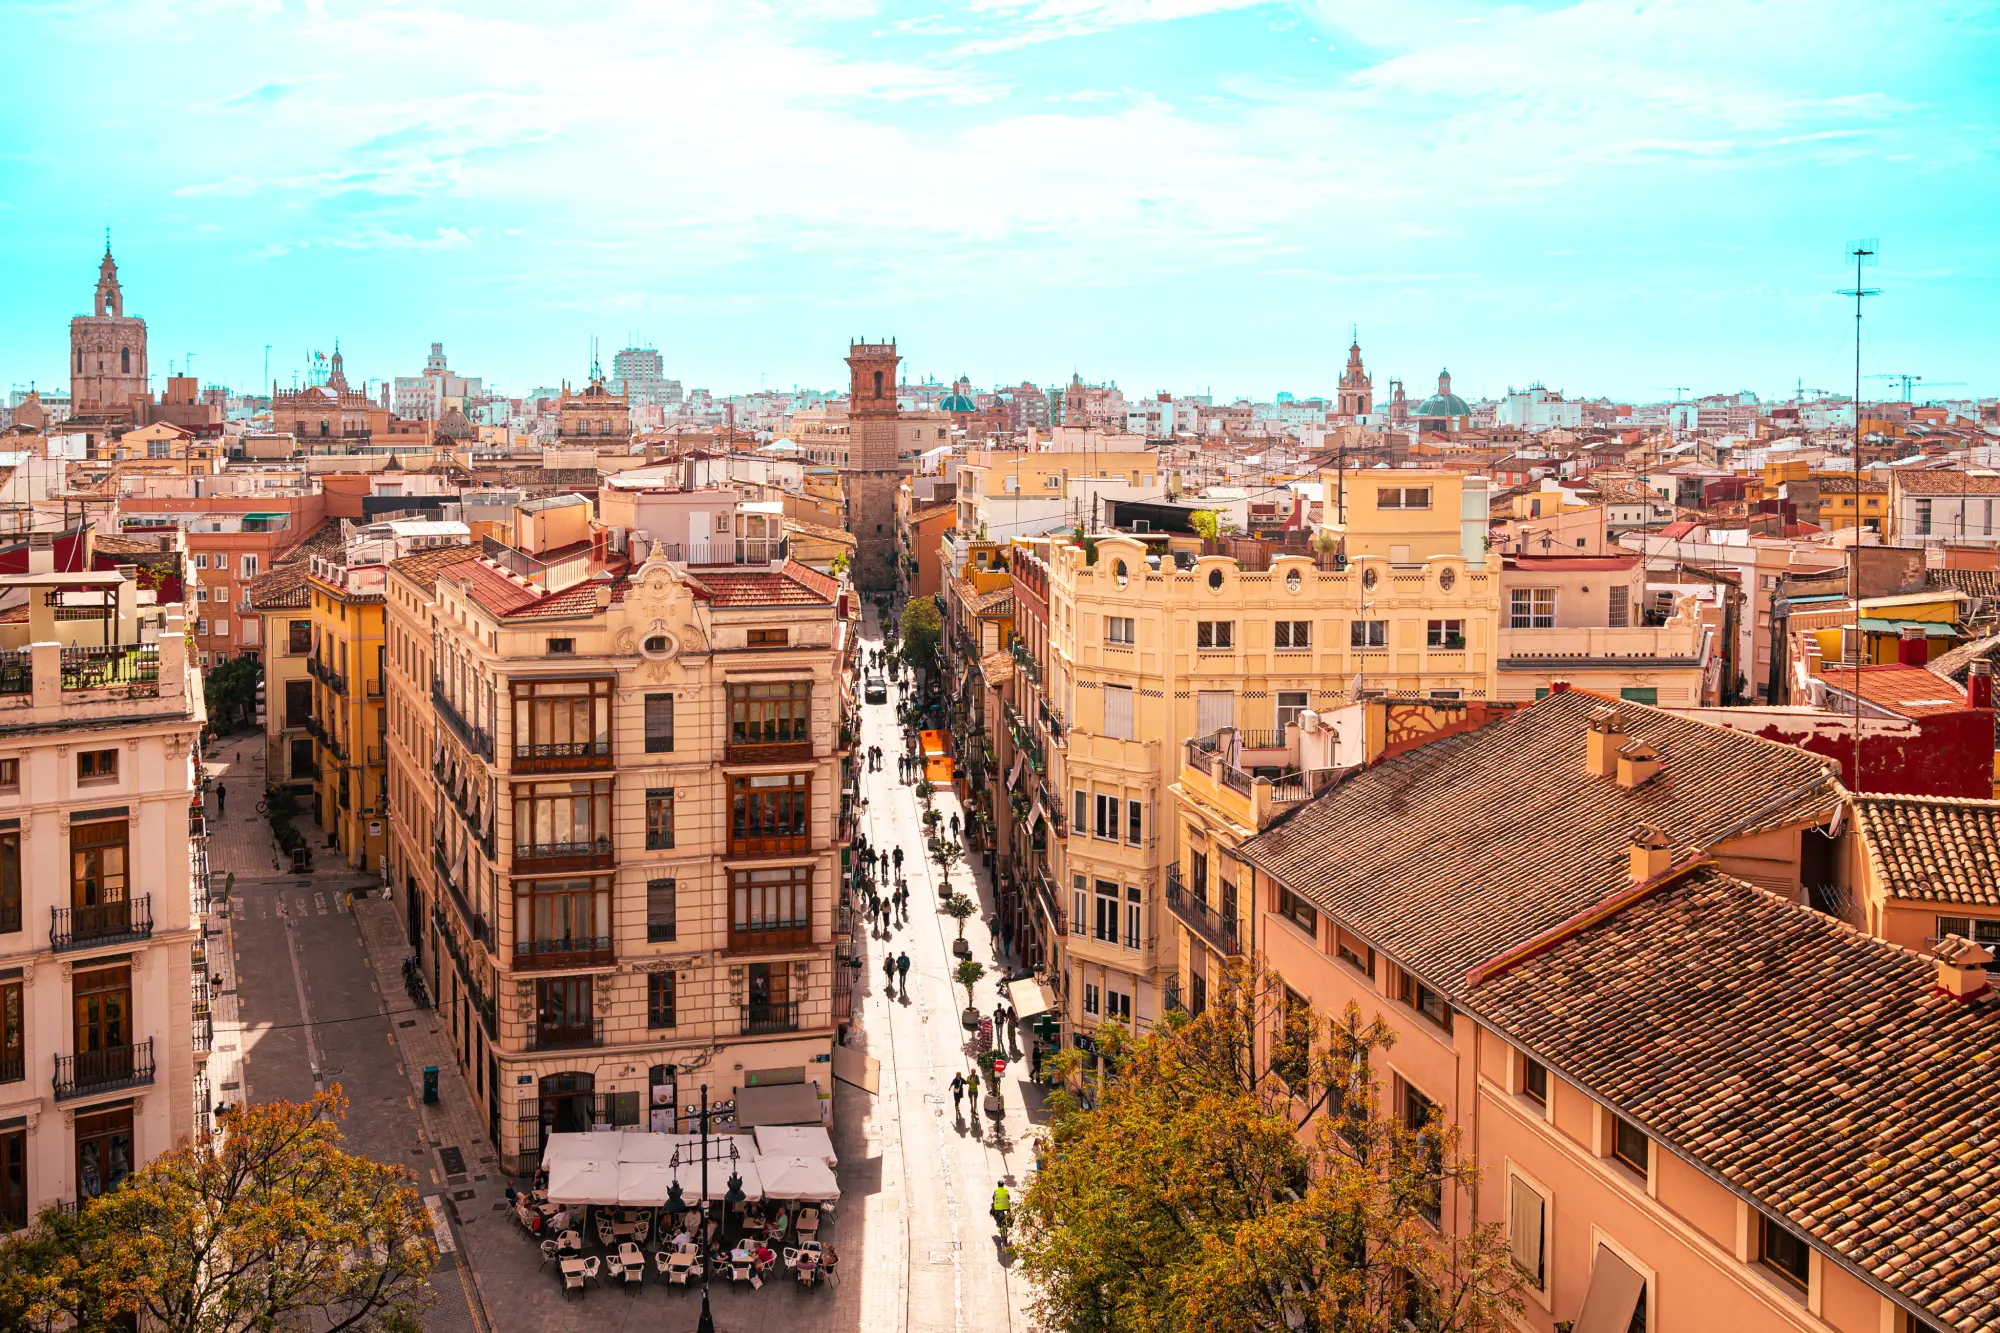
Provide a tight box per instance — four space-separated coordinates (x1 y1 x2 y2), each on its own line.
1468 857 2000 1333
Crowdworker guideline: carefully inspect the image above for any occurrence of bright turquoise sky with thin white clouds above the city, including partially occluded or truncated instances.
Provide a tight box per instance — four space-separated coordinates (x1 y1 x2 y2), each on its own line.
0 0 2000 400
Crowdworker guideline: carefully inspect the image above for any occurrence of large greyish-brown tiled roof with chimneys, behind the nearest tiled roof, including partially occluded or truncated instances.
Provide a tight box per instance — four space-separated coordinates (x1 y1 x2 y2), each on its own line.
1238 689 1832 993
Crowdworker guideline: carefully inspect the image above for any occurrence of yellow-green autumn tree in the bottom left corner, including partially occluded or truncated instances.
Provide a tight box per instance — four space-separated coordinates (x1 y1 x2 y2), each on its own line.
0 1087 438 1333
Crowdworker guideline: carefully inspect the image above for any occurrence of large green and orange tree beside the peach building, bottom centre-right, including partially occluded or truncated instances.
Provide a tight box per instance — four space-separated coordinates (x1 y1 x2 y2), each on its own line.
1018 963 1520 1333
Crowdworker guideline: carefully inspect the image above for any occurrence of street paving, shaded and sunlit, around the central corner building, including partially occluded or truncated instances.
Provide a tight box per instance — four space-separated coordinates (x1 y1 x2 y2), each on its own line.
208 612 1040 1333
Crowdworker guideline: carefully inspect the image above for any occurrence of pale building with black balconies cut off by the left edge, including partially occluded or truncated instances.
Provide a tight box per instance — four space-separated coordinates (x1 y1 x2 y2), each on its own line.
0 538 210 1229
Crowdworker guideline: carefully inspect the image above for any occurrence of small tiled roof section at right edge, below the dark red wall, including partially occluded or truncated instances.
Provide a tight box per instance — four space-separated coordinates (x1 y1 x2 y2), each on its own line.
1854 795 2000 907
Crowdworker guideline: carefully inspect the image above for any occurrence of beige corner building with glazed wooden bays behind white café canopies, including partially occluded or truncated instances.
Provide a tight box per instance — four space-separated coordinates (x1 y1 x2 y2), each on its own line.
388 510 854 1171
